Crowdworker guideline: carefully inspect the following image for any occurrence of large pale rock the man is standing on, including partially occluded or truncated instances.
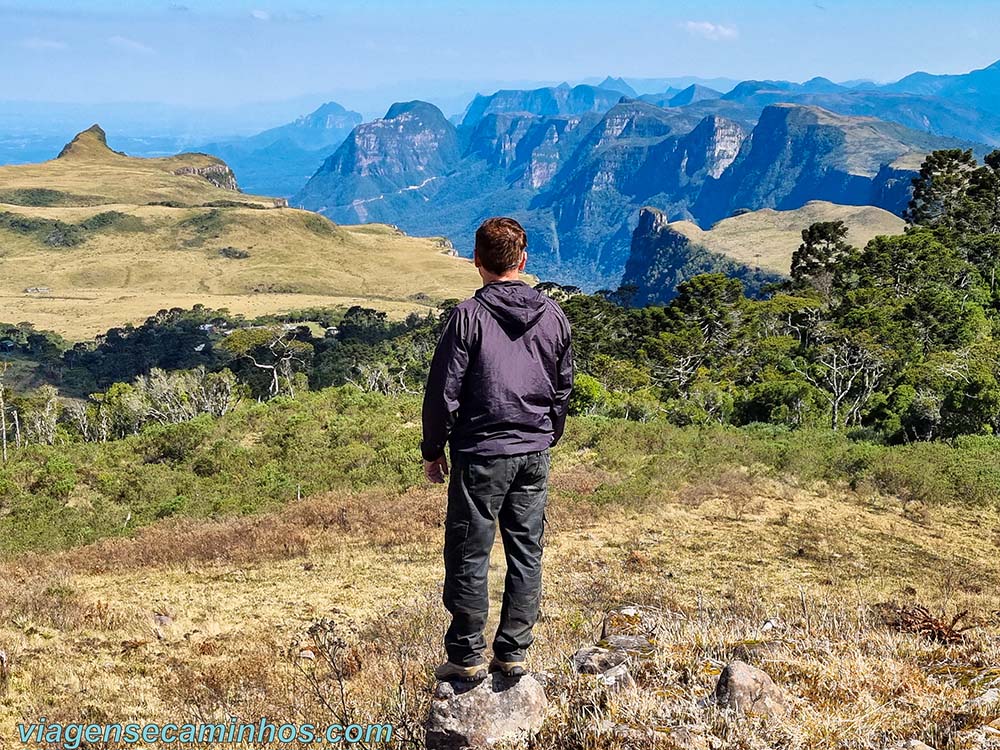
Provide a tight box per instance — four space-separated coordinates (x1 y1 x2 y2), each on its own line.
427 673 548 750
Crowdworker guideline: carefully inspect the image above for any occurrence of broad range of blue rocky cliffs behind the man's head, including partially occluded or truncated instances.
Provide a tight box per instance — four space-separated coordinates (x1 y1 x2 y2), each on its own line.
293 95 964 288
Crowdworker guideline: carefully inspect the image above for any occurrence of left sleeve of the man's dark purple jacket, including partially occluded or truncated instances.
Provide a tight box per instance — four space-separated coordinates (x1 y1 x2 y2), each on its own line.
420 310 469 461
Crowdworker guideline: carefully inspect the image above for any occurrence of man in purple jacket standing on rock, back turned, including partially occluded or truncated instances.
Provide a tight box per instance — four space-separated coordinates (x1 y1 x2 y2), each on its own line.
420 218 573 680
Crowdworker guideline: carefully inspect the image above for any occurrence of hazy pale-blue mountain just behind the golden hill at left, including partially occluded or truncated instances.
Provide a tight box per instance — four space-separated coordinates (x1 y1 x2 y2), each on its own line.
200 102 361 197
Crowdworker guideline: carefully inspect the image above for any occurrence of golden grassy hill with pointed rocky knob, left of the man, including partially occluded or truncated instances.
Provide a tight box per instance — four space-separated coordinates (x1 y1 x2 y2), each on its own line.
0 128 478 338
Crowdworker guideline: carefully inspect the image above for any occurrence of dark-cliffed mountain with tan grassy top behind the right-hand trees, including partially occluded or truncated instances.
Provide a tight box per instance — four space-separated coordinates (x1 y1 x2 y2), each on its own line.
622 201 905 305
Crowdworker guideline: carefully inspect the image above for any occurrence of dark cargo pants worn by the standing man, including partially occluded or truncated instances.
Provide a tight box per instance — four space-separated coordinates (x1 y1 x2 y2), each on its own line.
444 450 549 666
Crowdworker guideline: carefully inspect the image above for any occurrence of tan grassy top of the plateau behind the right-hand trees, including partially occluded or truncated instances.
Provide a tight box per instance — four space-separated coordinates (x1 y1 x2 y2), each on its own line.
670 201 905 275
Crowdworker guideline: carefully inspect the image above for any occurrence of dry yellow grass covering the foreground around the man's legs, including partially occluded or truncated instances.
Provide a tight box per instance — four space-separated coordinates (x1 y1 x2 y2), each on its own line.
0 468 1000 750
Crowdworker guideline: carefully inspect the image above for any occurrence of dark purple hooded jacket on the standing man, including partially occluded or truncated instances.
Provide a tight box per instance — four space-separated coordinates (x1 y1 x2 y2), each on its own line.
420 281 573 461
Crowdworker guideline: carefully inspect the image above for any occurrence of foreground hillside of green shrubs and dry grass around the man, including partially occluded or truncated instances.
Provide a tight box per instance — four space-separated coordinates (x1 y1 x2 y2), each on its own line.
0 389 1000 750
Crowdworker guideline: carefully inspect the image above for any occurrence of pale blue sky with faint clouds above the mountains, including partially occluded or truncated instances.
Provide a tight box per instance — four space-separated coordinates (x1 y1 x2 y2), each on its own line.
0 0 1000 106
